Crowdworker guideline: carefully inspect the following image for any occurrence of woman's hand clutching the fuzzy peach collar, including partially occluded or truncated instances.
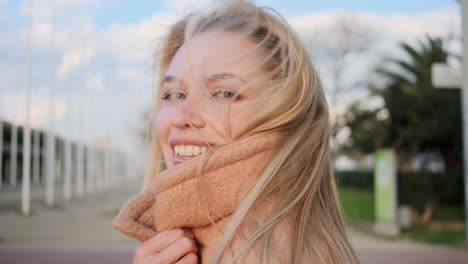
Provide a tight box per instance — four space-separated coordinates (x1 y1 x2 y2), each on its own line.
133 229 198 264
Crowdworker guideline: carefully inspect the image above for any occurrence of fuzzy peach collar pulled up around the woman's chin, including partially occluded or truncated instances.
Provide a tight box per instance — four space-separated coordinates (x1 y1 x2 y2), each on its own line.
113 132 281 241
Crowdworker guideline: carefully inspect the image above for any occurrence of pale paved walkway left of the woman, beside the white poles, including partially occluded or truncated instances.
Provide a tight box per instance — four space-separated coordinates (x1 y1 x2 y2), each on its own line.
0 179 139 249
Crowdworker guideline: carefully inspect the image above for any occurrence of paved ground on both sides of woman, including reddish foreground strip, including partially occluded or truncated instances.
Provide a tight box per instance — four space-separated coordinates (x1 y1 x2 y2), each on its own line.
0 182 468 264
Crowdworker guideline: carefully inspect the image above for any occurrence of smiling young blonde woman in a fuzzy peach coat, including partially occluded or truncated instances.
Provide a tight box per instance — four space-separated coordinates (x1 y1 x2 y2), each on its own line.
114 0 358 264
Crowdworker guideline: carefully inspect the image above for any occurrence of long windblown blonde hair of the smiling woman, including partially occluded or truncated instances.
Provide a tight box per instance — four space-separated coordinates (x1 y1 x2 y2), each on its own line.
144 0 359 263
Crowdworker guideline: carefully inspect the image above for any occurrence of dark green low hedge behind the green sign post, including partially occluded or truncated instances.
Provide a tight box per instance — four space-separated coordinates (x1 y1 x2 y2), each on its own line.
335 170 463 209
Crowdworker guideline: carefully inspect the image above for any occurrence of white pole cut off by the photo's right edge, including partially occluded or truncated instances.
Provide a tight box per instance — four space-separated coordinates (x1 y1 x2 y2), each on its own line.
460 0 468 243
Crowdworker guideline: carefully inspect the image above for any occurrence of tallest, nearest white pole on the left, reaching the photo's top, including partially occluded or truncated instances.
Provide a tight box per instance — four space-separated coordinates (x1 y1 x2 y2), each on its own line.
46 0 56 207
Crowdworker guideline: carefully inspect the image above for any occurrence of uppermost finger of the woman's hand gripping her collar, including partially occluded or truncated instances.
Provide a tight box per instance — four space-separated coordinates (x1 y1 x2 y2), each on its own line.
135 229 186 259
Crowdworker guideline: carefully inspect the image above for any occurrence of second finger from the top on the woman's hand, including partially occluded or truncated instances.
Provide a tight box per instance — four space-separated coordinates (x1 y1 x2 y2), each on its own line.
154 237 198 263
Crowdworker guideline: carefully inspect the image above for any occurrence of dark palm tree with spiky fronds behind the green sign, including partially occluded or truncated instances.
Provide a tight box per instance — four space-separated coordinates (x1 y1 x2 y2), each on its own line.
347 36 462 170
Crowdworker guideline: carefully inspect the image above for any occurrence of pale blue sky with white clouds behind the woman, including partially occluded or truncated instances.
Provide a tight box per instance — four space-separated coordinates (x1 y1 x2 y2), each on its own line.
0 0 460 157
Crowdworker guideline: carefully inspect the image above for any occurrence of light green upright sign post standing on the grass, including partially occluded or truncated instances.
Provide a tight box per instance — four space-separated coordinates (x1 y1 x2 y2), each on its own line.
374 149 400 235
